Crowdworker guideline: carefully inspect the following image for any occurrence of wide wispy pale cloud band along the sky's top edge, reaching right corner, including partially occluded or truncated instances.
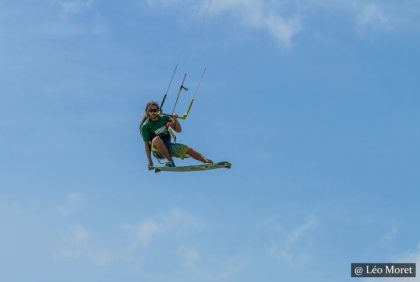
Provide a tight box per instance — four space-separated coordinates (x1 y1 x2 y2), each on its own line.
143 0 420 48
